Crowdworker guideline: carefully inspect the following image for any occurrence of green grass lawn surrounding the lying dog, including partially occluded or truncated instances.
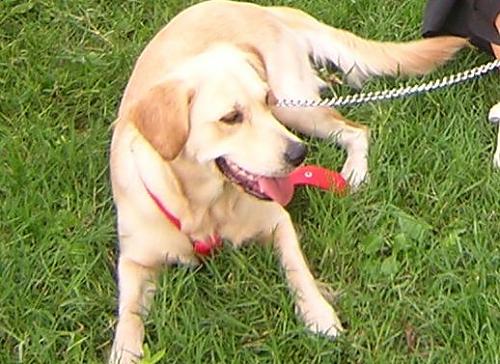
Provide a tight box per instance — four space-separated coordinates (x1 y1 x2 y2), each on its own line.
0 0 500 364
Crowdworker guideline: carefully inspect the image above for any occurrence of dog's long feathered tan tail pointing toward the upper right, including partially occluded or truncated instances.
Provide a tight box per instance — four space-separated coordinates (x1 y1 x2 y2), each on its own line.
272 8 467 86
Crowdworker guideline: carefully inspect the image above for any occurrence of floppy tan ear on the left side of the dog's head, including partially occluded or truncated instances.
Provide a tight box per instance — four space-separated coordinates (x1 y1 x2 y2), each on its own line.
128 80 194 160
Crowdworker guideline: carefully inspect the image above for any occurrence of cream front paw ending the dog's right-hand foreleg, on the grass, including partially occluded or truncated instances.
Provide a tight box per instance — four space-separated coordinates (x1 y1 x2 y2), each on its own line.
296 299 344 339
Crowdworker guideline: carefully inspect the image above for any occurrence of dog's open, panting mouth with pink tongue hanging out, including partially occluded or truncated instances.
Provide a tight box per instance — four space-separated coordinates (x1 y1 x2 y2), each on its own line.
215 157 293 206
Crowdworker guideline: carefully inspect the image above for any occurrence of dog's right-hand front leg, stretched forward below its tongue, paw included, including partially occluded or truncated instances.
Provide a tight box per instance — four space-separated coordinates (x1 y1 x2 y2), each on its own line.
274 210 343 337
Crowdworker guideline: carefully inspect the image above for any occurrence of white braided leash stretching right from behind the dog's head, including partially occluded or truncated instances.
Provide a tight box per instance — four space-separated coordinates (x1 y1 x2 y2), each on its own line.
277 59 500 107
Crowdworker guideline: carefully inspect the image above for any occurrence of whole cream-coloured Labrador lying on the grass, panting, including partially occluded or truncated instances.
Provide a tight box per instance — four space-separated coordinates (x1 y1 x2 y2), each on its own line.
110 0 466 363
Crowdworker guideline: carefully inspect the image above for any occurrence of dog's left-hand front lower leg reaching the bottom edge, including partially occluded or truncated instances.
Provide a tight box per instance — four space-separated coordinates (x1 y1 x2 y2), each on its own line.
109 257 157 364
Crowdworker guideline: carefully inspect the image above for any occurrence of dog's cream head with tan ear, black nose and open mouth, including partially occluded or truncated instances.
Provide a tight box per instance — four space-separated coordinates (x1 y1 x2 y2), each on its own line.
129 47 306 203
